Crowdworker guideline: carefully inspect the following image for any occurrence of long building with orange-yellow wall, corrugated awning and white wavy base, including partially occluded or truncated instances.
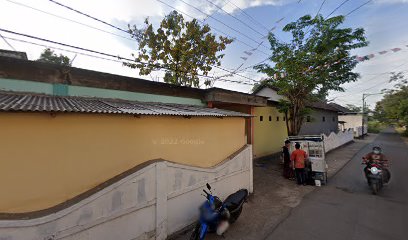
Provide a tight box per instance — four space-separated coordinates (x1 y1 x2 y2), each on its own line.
0 57 255 240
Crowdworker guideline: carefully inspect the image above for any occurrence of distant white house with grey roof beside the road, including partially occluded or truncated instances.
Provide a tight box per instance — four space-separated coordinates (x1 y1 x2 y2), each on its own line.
330 103 368 137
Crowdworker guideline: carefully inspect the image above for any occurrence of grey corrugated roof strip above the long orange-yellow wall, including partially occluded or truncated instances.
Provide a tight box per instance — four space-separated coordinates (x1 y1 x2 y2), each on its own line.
0 92 251 117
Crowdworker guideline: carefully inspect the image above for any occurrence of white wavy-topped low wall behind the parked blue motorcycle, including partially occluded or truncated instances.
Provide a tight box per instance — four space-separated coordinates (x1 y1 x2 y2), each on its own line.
0 145 253 240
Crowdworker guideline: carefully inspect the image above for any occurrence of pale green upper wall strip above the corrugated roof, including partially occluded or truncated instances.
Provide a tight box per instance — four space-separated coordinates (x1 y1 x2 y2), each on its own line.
0 78 205 106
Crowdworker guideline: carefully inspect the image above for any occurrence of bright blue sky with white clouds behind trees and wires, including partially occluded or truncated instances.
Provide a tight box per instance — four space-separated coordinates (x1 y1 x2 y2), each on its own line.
0 0 408 108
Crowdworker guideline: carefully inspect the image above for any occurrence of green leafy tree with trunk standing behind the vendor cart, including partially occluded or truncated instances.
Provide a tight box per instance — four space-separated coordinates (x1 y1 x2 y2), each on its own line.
254 15 368 135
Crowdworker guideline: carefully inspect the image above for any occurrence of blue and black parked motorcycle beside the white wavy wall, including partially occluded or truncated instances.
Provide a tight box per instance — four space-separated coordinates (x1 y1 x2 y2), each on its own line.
190 183 248 240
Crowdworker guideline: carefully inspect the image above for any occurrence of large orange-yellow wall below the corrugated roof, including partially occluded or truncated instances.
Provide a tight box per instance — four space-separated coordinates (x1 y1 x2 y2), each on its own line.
0 113 246 213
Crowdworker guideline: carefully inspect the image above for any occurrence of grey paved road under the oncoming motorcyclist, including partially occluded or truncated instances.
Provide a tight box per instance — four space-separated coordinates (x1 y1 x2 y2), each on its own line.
267 130 408 240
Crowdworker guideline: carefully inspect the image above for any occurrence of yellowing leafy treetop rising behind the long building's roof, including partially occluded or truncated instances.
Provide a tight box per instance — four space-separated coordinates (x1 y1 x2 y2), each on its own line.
124 11 232 87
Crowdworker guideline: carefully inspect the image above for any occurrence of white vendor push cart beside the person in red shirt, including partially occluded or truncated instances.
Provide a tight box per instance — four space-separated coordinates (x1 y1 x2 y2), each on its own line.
288 135 328 185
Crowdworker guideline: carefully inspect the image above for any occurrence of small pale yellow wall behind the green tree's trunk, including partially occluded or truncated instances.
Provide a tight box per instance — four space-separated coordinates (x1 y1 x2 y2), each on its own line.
253 107 288 157
